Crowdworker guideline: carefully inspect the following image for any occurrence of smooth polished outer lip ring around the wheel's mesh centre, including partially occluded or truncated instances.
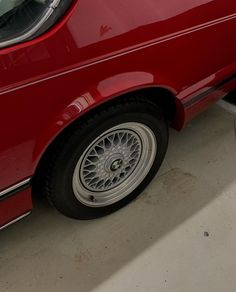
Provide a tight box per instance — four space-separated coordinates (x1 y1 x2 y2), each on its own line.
72 122 157 207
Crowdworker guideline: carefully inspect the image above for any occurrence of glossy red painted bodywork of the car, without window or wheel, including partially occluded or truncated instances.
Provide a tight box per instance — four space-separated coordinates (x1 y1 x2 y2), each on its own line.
0 0 236 225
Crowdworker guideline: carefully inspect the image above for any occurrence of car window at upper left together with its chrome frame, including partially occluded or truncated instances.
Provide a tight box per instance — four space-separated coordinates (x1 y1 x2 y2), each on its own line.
0 0 71 47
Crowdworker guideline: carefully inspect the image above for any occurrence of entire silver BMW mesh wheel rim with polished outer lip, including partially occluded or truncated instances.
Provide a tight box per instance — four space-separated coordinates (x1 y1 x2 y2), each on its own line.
72 123 157 207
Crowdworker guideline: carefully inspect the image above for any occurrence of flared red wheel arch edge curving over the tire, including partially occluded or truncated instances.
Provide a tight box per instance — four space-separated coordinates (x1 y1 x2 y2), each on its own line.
33 71 180 171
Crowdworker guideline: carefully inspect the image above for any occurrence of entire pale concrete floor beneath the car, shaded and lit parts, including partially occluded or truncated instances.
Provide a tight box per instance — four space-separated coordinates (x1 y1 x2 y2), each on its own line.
0 106 236 292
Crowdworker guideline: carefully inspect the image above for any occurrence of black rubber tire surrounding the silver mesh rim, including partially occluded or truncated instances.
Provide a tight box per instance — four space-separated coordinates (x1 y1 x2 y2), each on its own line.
43 99 169 220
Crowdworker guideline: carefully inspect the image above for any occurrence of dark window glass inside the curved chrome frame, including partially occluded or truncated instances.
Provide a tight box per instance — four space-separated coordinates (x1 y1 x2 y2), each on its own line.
0 0 49 42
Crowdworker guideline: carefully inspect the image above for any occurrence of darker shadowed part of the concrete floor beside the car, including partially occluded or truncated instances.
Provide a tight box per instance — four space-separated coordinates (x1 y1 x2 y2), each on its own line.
0 106 236 292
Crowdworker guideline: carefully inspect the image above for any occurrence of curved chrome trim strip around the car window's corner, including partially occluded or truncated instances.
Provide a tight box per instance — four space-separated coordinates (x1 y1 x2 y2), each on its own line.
0 0 61 48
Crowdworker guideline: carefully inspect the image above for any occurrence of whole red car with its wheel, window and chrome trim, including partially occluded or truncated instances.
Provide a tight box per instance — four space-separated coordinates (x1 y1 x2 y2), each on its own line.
0 0 236 228
